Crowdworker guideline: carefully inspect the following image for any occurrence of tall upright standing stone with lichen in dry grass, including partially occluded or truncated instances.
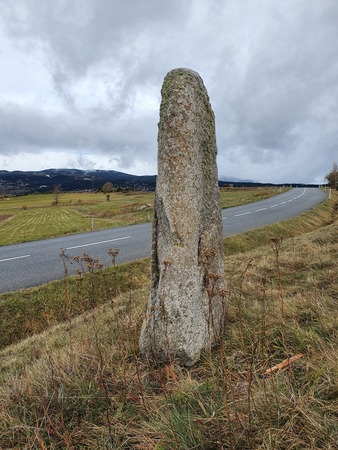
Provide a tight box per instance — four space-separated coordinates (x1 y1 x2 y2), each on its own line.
140 69 226 366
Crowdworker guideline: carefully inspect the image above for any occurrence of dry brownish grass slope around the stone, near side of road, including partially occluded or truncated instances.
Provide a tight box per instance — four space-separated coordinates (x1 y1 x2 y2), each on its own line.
0 189 338 450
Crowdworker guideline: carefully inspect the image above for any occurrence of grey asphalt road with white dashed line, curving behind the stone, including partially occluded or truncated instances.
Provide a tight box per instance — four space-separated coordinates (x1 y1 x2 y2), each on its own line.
0 188 326 293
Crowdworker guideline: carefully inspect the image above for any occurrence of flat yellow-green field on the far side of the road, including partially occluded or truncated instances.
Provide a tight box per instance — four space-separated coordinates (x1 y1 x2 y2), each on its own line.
0 188 286 245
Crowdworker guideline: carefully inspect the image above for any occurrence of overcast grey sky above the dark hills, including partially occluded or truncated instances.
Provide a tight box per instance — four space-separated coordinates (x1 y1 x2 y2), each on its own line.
0 0 338 184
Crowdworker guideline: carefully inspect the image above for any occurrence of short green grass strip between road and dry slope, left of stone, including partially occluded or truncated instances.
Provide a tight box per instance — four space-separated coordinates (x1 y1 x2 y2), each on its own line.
0 255 150 349
